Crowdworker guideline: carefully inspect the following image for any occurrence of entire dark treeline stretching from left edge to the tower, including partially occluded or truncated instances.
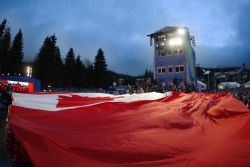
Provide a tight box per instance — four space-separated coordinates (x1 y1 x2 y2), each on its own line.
0 19 153 88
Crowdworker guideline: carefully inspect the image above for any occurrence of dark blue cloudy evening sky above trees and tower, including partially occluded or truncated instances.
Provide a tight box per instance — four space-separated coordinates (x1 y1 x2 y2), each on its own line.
0 0 250 75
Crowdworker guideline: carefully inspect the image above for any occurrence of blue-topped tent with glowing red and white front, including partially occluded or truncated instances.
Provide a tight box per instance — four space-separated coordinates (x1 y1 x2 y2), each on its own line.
0 75 41 93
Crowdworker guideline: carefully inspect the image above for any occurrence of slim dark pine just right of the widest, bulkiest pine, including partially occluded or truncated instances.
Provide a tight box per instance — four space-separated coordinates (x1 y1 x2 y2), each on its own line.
64 48 76 86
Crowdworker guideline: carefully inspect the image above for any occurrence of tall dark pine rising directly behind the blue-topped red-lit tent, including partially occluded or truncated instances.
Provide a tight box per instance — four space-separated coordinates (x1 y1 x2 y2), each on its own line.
10 29 23 74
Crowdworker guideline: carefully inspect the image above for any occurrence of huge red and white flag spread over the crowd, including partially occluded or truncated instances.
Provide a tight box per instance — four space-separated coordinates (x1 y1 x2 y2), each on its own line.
9 93 250 167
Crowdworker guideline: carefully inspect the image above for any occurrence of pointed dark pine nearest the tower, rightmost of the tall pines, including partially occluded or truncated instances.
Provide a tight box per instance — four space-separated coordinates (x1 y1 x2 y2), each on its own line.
94 49 110 88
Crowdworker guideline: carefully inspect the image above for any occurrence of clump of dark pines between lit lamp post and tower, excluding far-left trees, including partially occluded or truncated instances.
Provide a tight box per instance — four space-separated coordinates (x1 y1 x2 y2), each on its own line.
33 35 112 88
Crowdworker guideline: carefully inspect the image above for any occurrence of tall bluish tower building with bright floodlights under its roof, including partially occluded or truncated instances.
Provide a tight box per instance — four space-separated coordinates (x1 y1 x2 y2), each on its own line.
148 27 197 85
